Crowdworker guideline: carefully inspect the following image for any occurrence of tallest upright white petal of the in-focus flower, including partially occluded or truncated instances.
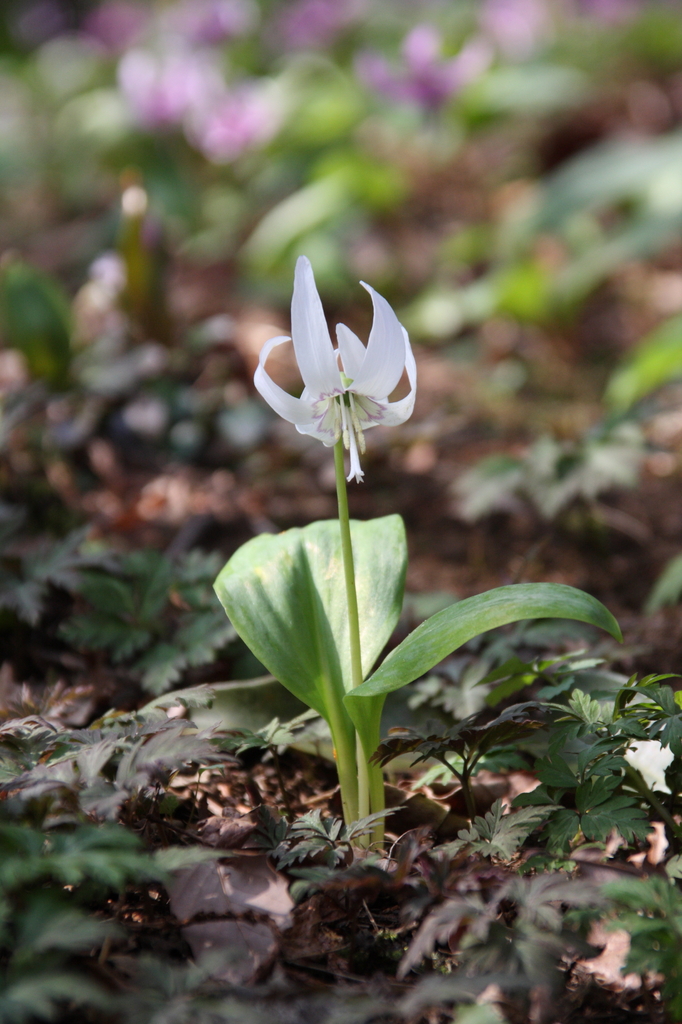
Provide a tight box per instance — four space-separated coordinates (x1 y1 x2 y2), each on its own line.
291 256 343 396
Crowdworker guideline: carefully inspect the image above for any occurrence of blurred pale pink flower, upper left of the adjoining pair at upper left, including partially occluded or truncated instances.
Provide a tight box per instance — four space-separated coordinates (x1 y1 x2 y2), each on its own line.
119 49 223 128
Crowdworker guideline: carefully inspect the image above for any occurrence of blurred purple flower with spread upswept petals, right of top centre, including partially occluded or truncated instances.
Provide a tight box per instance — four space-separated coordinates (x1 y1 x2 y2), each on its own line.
356 25 493 110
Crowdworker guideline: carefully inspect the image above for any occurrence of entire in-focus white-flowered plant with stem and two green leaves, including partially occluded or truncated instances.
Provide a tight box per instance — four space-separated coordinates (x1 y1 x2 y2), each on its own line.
215 257 621 842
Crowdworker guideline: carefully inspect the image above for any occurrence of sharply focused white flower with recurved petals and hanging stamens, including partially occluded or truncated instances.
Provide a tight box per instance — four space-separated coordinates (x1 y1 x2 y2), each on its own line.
254 256 417 483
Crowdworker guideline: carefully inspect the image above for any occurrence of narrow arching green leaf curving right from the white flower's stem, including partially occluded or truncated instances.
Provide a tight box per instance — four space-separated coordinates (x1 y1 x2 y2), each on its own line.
345 583 622 725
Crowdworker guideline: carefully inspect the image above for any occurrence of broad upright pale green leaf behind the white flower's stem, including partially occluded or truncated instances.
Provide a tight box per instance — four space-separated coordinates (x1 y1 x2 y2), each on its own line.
215 515 407 770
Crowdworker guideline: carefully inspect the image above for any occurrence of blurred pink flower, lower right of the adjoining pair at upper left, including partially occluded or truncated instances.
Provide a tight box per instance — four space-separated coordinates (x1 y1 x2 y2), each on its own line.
187 82 281 164
